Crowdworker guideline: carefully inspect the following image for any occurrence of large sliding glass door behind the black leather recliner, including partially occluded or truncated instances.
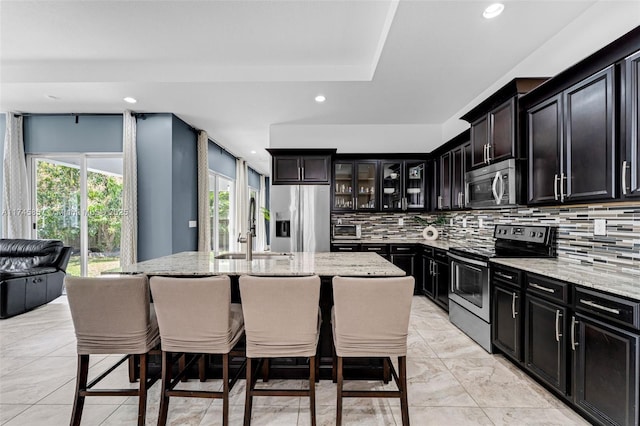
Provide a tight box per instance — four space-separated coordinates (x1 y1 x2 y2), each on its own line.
29 154 126 277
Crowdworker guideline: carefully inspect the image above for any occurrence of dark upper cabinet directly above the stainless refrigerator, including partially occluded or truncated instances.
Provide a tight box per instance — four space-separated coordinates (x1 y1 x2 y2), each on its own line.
267 149 336 185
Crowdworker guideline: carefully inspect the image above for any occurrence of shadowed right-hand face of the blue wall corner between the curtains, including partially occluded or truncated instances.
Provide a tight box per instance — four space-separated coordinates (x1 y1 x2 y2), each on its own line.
171 116 198 253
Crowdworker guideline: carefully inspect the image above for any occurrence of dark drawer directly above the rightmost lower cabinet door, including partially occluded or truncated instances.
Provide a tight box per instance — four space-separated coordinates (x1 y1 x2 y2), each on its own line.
575 287 640 329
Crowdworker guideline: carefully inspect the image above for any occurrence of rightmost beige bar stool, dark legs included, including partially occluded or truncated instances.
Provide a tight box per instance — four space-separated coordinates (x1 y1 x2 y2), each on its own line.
331 277 414 426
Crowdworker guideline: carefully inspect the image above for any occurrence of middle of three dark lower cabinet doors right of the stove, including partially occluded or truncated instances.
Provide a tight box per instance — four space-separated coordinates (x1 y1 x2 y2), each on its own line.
524 294 568 395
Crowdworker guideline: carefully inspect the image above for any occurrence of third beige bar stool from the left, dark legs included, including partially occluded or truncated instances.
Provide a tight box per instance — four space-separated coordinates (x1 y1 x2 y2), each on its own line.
240 275 321 426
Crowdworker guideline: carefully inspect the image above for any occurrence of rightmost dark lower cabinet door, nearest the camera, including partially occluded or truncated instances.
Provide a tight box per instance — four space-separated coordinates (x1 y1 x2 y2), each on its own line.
571 314 640 426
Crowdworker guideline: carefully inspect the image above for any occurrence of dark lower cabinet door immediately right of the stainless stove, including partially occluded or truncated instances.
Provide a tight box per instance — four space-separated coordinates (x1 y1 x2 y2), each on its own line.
491 281 522 361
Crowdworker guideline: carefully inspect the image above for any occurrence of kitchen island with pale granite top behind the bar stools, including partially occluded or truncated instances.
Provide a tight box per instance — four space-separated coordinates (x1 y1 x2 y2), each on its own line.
105 252 406 379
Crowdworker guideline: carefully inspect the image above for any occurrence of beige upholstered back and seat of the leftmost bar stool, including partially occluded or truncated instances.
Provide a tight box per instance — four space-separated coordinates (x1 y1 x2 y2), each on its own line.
65 275 160 355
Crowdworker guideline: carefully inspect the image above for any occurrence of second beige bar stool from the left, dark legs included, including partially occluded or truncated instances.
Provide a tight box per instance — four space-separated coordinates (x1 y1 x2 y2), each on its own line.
150 276 244 426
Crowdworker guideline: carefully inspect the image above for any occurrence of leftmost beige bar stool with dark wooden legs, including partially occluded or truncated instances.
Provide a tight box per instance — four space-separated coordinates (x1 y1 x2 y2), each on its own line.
65 275 160 425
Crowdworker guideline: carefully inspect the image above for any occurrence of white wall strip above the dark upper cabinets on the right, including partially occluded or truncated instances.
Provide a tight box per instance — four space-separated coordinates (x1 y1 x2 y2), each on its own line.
441 0 640 142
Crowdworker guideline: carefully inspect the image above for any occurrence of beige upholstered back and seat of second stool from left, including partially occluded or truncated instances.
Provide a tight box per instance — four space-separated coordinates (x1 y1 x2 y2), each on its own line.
151 276 244 353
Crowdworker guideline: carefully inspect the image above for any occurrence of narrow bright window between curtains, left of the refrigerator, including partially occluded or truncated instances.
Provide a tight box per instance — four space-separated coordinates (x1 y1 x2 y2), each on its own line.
209 173 235 252
